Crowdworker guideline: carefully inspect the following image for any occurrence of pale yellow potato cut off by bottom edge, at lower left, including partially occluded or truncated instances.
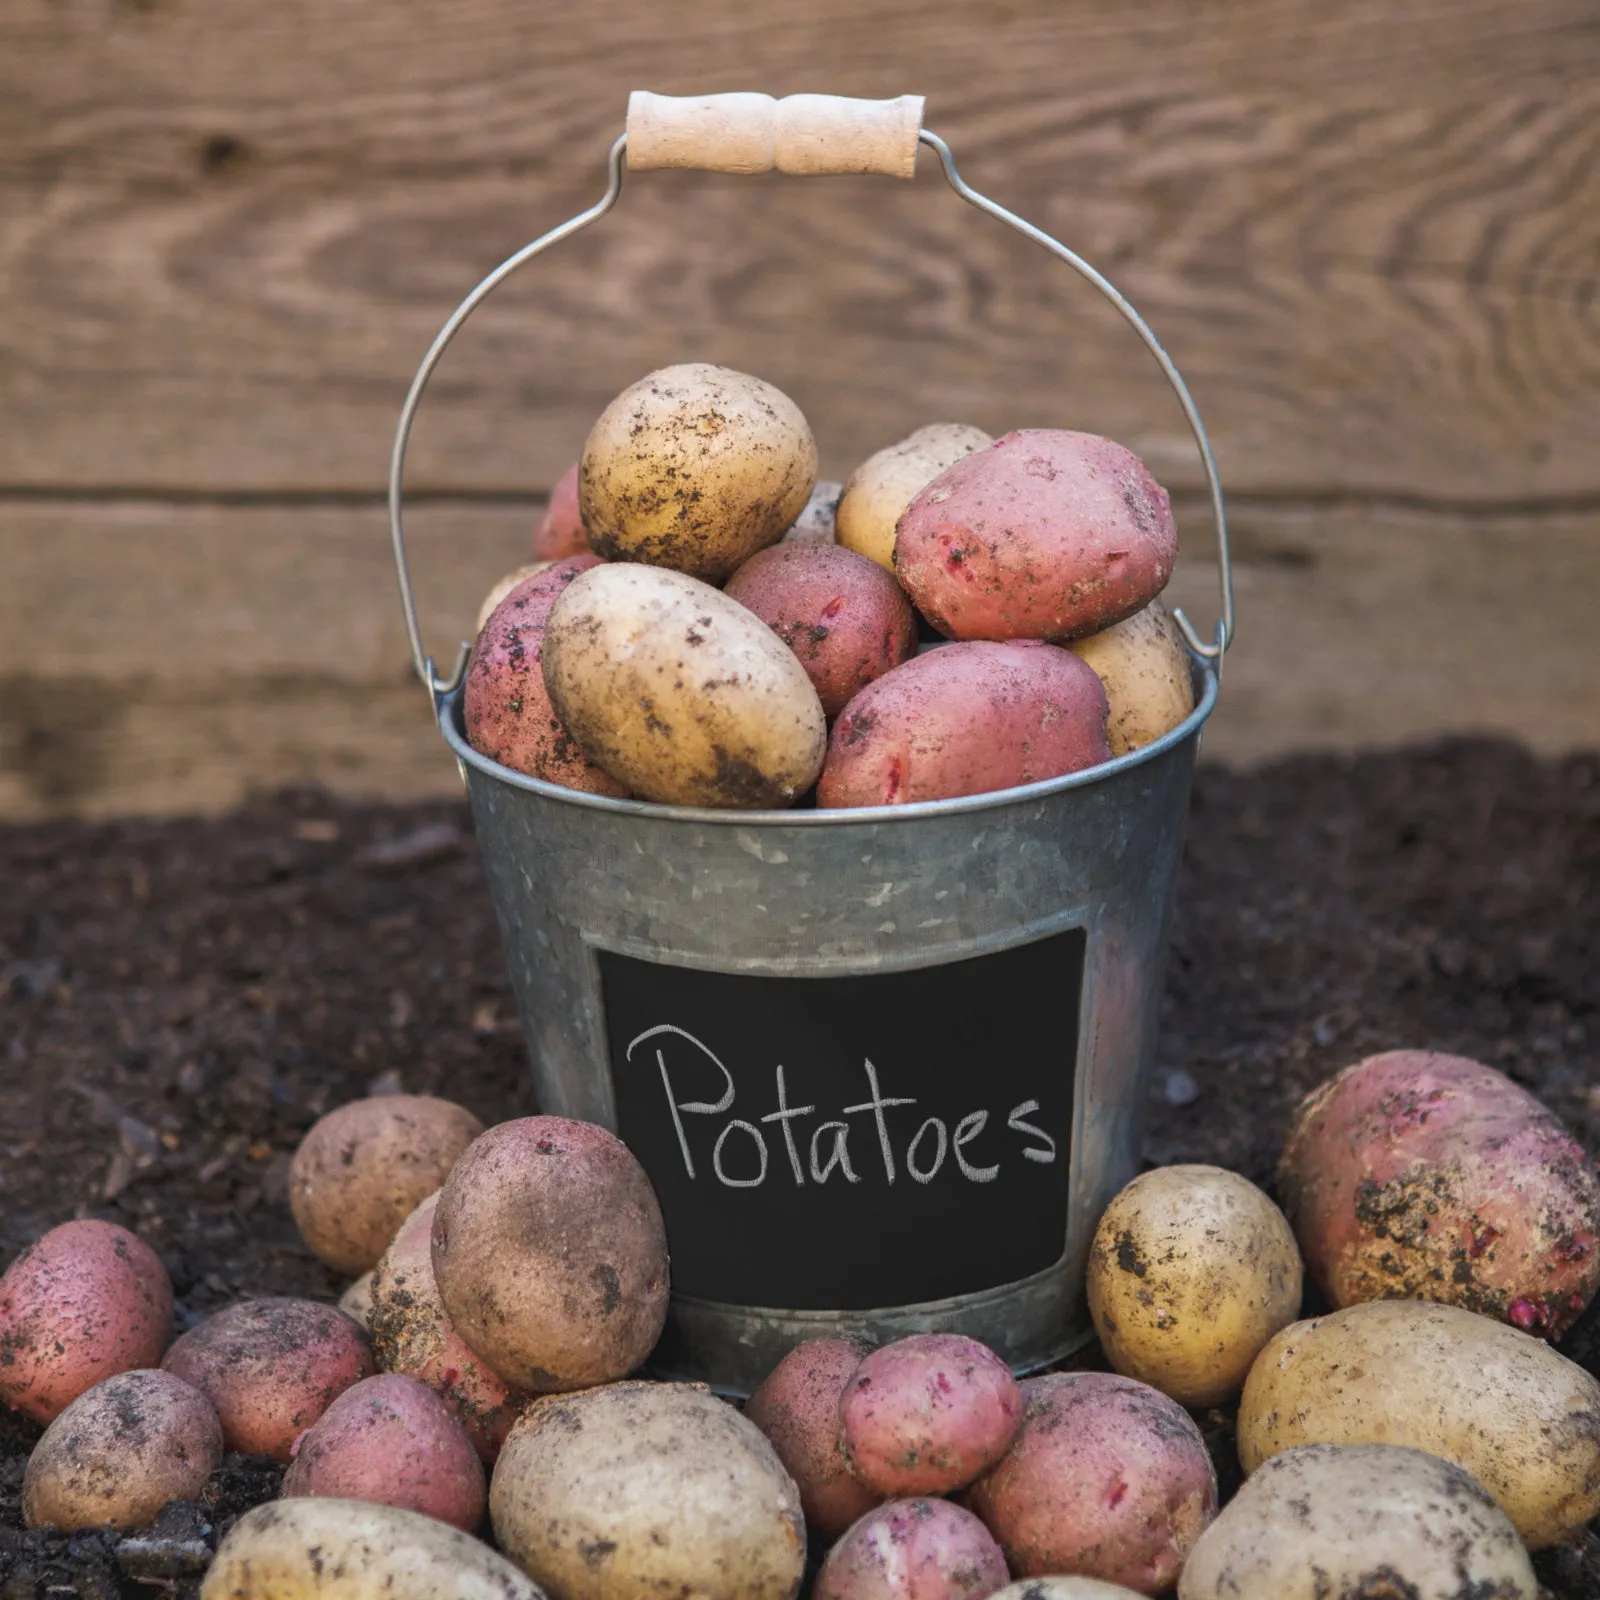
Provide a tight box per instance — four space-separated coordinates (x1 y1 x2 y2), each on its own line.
200 1499 546 1600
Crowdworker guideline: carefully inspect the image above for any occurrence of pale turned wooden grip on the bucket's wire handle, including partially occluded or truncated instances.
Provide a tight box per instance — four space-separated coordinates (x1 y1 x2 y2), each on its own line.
627 90 922 178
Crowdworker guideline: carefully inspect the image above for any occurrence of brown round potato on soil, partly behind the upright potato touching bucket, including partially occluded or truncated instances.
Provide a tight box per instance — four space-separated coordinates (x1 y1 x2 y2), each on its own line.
290 1094 483 1274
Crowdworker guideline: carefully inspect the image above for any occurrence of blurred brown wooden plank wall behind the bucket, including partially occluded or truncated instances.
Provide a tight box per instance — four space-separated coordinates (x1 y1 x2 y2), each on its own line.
0 0 1600 818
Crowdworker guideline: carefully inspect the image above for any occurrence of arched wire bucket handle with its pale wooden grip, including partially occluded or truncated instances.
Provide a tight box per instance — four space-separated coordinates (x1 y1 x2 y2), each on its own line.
389 90 1234 706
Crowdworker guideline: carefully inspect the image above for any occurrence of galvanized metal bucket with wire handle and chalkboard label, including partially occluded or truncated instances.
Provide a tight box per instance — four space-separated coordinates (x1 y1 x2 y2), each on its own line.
380 96 1232 1394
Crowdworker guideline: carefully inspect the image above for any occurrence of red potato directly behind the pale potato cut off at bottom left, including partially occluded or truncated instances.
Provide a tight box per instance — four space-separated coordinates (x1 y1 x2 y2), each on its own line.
283 1373 488 1533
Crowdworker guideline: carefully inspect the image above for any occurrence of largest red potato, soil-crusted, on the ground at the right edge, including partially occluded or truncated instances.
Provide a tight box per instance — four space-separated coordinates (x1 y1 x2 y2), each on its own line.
1278 1050 1600 1339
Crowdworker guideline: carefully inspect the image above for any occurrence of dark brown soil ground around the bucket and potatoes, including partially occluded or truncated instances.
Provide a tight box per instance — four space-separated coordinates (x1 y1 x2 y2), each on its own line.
0 742 1600 1600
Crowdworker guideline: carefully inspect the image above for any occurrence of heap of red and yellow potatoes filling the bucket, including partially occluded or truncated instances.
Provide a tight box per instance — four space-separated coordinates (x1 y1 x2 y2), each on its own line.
462 365 1194 810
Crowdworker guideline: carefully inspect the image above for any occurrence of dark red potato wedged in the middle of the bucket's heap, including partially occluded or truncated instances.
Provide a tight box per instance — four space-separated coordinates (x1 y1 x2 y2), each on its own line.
723 544 917 718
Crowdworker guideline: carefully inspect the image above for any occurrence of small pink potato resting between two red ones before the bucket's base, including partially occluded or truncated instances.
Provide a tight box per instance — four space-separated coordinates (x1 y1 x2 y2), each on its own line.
838 1333 1022 1494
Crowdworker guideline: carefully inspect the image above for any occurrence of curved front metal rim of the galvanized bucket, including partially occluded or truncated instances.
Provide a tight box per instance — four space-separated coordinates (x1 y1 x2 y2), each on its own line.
437 656 1219 827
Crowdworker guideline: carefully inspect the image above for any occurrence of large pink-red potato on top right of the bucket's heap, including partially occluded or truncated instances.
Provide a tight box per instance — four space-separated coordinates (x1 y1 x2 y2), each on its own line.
894 427 1178 643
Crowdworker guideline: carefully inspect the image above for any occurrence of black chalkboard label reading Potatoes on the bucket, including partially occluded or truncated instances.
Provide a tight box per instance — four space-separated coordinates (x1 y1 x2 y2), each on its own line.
598 928 1085 1310
